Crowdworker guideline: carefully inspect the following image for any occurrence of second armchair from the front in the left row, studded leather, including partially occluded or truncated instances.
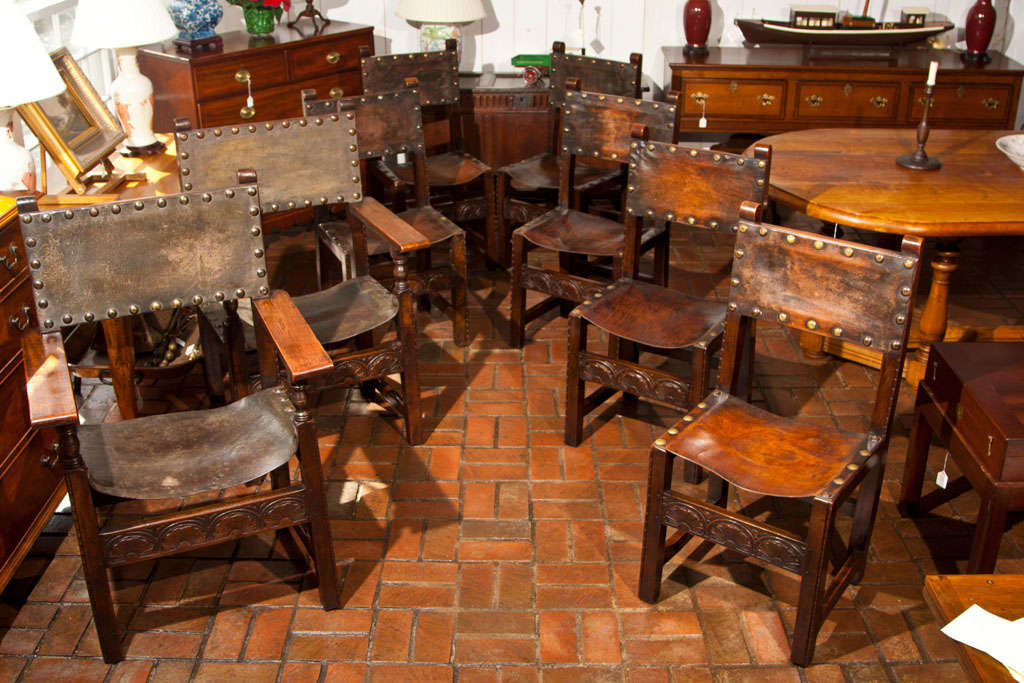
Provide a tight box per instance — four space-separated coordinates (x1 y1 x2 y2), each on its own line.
175 104 430 444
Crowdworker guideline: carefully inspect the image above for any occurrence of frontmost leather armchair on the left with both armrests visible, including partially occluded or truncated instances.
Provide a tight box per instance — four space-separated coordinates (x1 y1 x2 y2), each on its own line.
18 173 339 663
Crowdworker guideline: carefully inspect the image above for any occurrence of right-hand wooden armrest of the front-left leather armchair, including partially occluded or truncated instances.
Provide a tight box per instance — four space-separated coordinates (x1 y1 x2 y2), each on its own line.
253 290 334 382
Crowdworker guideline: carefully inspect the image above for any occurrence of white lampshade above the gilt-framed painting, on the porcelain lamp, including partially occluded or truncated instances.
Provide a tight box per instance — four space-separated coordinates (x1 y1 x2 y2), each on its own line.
71 0 178 49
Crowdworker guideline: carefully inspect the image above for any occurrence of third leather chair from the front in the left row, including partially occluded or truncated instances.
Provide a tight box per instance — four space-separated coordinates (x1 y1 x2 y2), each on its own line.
302 87 469 346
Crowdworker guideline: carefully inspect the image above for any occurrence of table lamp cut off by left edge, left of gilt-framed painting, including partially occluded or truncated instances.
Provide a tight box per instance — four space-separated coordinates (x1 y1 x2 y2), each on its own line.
0 0 68 191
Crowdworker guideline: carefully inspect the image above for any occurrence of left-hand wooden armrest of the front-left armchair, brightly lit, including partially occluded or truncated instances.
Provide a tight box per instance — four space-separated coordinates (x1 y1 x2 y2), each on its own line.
22 330 78 428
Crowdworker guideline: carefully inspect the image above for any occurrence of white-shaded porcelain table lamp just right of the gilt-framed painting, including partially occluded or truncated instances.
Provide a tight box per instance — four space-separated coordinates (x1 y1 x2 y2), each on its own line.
71 0 177 157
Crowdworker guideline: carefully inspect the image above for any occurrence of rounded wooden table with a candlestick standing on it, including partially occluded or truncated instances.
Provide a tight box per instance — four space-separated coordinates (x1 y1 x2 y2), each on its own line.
749 128 1024 384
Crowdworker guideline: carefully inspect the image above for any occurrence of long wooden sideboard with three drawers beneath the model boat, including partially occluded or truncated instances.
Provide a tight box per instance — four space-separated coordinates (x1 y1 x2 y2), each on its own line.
662 47 1024 133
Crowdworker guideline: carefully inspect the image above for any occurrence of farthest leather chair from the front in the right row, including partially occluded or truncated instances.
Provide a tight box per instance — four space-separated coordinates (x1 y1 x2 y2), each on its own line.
488 41 638 266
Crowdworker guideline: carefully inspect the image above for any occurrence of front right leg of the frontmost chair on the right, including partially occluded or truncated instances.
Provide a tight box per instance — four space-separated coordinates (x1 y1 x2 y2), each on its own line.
790 500 836 667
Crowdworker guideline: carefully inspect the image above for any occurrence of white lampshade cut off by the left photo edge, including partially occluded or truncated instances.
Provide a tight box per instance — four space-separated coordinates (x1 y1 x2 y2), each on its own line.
0 0 68 106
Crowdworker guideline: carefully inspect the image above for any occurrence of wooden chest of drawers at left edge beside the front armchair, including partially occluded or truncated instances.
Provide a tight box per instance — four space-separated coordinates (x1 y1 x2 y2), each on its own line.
0 205 65 590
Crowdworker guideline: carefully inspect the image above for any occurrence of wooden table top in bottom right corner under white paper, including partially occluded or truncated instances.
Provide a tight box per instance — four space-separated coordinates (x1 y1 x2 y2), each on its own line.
925 573 1024 681
